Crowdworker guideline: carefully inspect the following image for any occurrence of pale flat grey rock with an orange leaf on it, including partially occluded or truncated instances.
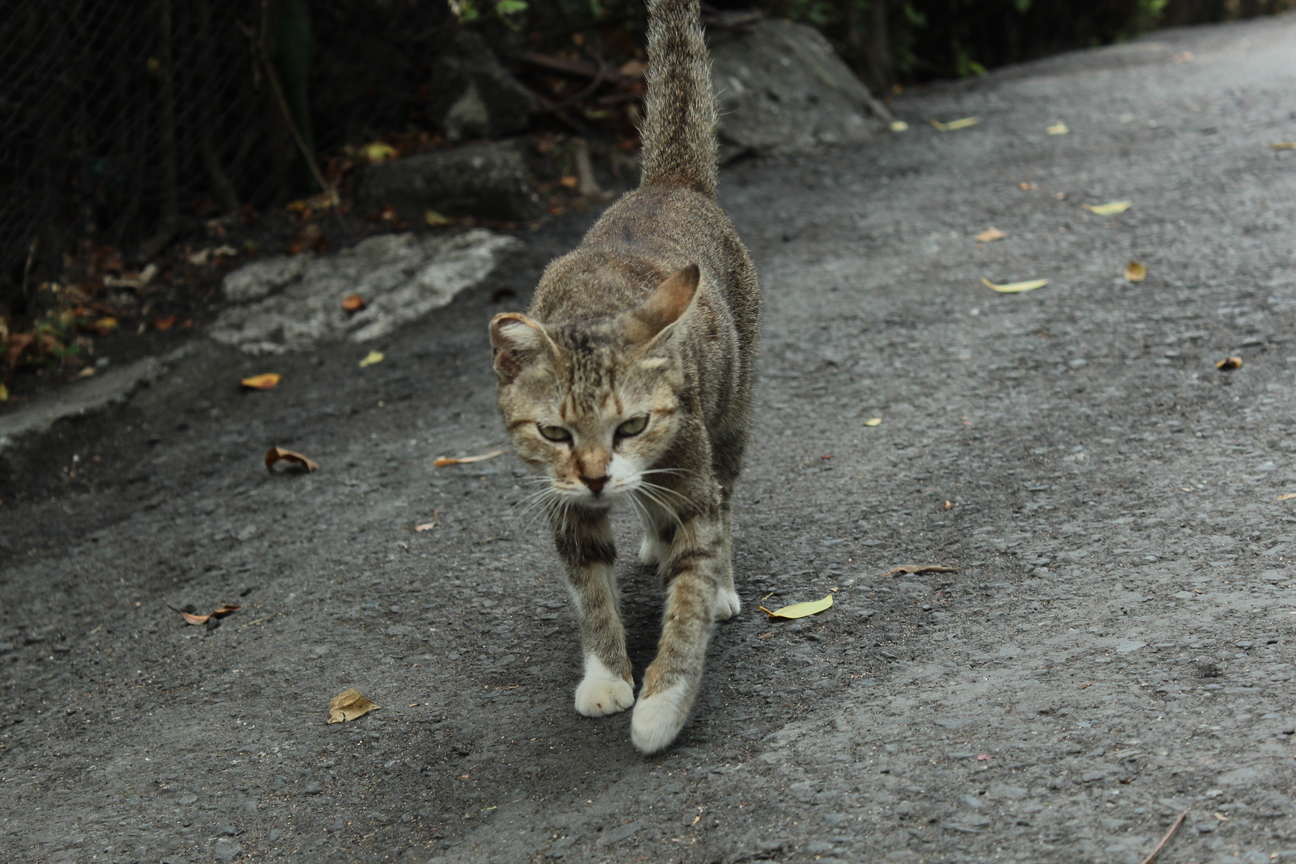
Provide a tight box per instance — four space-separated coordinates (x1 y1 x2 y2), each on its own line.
210 228 522 354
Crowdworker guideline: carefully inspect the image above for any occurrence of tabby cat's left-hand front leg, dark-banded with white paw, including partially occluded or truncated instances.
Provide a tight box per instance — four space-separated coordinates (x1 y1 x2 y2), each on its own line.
555 508 635 716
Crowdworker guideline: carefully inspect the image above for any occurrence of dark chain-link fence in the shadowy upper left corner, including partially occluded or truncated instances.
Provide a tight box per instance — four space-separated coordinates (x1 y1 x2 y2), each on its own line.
0 0 452 314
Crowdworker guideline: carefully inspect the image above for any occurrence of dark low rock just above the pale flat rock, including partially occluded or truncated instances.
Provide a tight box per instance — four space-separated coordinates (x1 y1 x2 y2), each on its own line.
356 140 544 222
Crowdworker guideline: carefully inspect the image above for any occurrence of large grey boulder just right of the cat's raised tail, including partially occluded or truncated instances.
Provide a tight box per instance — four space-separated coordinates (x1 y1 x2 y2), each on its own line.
712 19 892 162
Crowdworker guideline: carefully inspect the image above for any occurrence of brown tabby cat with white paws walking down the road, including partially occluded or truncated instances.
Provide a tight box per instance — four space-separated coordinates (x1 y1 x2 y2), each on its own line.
490 0 761 754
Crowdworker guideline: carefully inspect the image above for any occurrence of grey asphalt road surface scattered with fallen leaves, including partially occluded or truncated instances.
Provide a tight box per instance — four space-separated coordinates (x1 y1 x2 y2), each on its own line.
0 16 1296 864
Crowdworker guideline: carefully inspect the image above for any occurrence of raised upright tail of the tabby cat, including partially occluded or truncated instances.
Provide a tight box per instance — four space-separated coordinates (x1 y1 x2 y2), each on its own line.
640 0 719 197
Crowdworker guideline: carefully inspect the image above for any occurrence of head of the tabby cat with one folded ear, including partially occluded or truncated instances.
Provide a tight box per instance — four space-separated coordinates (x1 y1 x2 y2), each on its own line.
490 264 699 508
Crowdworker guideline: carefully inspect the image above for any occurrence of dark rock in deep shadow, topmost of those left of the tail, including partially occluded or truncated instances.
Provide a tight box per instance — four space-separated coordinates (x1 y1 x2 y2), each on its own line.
429 30 540 142
